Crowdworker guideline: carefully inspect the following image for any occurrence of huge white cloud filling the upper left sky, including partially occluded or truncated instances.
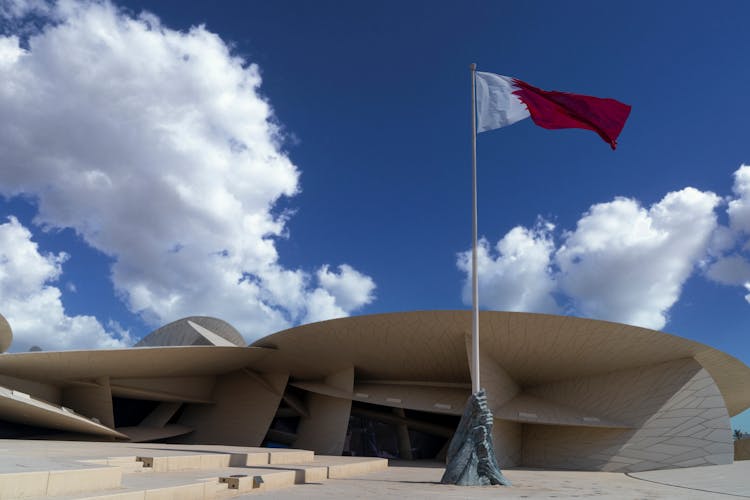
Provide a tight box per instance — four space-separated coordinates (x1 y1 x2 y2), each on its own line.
0 0 375 345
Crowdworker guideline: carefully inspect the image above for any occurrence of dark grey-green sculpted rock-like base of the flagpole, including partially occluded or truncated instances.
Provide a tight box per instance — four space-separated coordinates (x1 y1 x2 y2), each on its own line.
440 390 510 486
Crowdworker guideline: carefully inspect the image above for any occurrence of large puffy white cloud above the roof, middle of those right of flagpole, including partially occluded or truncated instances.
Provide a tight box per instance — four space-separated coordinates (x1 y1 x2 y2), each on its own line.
556 188 720 329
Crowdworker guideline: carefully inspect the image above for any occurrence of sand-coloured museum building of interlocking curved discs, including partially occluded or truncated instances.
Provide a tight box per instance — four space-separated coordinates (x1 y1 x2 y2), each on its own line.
0 311 750 472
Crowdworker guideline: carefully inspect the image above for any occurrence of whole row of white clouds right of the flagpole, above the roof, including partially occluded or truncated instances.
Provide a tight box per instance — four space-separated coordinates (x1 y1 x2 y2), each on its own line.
457 170 750 329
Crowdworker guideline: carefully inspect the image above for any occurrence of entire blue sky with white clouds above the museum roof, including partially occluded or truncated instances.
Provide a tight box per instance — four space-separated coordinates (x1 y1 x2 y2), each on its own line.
0 0 750 430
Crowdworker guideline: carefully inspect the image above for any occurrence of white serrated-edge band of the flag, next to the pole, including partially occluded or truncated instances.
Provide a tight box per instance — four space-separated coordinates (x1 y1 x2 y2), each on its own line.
476 71 530 132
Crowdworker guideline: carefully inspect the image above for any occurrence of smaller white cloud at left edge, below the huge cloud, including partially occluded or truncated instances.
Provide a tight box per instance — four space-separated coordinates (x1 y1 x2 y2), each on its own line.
0 217 130 351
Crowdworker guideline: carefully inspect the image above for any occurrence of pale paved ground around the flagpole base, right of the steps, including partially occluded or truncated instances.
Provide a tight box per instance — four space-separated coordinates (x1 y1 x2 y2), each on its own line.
247 461 750 500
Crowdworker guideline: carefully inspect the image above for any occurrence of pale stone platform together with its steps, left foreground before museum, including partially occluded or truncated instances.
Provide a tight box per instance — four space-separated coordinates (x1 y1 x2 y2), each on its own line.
0 440 388 500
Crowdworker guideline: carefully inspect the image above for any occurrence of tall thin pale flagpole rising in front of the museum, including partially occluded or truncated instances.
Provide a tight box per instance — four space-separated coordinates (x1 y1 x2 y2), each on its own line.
471 63 481 394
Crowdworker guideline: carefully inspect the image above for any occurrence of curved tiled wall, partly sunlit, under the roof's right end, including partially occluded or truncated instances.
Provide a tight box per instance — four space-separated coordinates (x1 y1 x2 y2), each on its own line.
523 359 733 472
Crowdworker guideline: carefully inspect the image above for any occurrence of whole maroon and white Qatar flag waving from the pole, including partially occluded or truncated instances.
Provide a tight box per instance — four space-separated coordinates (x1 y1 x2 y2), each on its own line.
476 71 630 149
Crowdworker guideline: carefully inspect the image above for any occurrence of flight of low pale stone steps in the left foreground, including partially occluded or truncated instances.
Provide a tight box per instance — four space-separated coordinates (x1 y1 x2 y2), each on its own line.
5 450 388 500
